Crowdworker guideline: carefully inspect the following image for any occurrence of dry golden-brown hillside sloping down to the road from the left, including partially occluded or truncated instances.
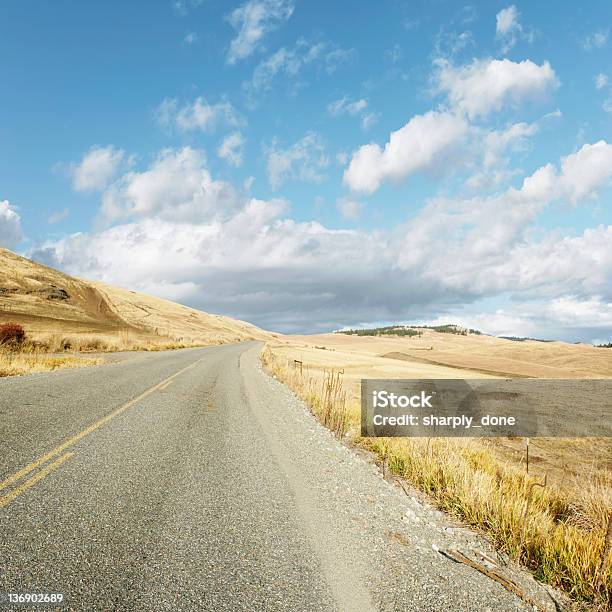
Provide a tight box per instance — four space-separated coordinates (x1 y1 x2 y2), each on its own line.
0 248 269 344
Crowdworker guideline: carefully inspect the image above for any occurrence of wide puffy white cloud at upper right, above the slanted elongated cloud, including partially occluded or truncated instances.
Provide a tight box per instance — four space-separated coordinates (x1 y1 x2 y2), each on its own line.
435 59 559 119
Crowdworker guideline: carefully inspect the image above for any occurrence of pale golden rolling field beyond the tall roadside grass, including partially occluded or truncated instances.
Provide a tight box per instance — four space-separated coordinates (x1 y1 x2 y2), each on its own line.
268 330 612 483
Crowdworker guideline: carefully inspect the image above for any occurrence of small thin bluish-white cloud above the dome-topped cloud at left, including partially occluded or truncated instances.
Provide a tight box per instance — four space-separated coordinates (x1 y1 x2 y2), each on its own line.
155 97 243 132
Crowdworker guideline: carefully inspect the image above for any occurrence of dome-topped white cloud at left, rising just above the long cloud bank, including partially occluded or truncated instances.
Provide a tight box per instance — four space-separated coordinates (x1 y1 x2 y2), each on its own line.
102 147 241 223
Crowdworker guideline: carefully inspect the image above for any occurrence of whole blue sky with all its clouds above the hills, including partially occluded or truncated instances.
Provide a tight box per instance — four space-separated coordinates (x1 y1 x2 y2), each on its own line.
0 0 612 342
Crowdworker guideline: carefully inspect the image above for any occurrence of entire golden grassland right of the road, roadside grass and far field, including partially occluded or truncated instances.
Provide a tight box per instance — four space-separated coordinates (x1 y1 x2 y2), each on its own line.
262 330 612 609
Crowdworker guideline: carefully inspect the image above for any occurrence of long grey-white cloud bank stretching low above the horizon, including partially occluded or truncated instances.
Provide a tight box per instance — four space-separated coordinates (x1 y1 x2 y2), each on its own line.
32 195 612 338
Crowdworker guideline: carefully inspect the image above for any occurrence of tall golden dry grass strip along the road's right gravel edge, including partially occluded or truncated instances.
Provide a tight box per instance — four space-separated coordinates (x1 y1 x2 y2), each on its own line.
262 348 612 608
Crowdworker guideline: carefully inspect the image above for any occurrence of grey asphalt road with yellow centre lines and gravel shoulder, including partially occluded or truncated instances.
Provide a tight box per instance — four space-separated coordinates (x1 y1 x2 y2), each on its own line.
0 343 556 612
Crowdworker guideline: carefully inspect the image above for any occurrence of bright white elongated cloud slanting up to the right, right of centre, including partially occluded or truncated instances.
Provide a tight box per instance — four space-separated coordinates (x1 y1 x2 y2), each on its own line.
344 111 468 193
